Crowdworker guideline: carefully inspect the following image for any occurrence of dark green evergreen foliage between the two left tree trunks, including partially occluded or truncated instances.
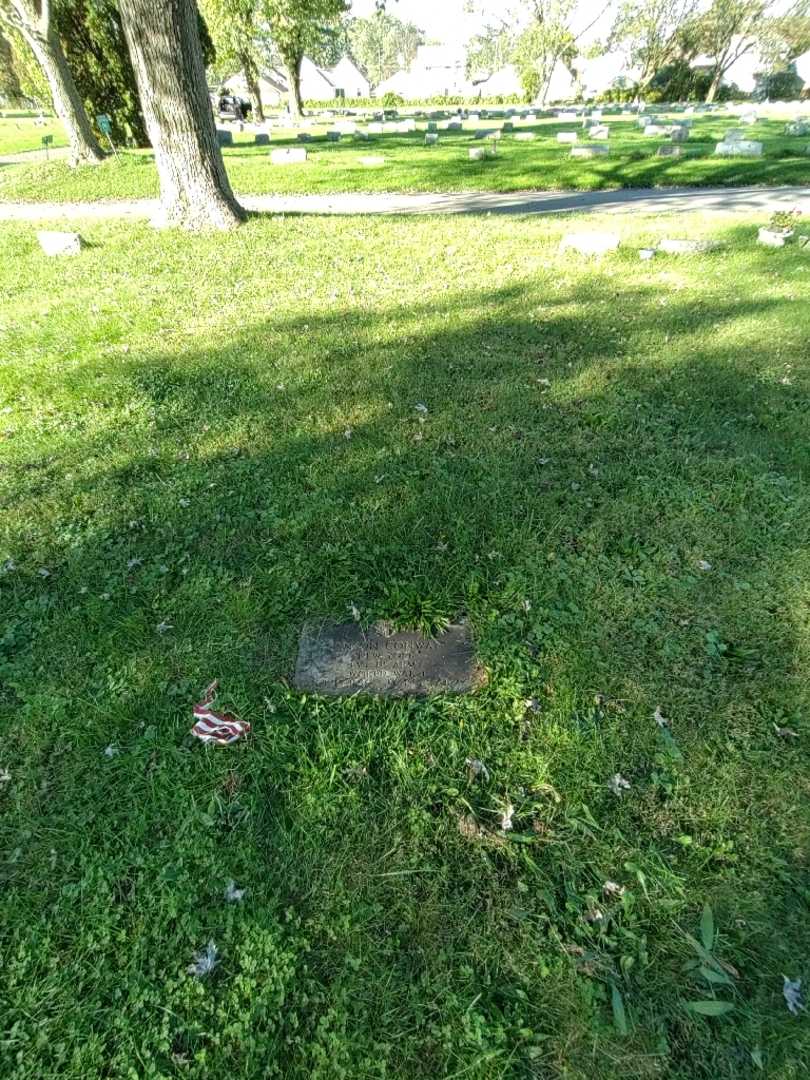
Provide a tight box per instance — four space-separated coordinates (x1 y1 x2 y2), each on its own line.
54 0 149 146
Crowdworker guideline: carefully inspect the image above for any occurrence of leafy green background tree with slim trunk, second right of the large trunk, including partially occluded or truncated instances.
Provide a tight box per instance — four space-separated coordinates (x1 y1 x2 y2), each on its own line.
259 0 349 120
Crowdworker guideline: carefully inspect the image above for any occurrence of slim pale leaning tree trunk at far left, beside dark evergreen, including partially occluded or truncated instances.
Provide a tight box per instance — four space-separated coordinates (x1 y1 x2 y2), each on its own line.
0 0 104 165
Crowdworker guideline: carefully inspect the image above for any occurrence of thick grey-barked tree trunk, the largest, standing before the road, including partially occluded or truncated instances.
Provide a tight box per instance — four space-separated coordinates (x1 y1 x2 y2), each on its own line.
120 0 245 229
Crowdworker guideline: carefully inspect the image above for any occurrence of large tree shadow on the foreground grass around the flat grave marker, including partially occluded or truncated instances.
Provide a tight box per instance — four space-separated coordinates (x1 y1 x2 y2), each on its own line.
4 261 808 1078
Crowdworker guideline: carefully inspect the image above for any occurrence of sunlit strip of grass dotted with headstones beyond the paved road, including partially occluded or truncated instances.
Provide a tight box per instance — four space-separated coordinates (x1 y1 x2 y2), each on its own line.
0 116 810 202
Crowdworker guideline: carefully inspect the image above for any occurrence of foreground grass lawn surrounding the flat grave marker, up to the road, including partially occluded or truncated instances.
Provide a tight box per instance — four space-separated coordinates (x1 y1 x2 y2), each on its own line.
0 206 810 1080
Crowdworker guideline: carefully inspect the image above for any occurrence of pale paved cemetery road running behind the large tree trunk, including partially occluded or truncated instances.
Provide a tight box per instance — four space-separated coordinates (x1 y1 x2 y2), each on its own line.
0 186 810 221
